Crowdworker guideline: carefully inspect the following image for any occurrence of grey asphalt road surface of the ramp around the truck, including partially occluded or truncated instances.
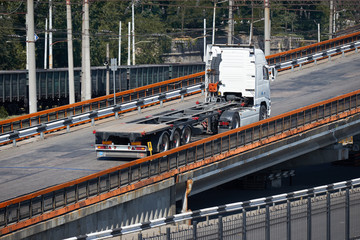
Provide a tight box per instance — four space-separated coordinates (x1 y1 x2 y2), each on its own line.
0 54 360 202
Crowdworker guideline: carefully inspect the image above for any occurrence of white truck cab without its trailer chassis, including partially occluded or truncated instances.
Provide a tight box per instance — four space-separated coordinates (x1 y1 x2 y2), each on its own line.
205 45 271 126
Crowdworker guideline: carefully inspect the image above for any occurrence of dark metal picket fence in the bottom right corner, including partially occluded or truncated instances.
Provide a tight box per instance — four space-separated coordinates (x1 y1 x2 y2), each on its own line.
139 179 360 240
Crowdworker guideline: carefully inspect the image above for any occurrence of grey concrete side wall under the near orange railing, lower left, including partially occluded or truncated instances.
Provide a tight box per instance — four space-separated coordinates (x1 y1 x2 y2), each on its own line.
0 178 175 240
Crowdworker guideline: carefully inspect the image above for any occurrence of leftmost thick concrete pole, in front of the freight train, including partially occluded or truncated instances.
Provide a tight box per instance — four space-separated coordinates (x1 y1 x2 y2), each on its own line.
26 0 37 113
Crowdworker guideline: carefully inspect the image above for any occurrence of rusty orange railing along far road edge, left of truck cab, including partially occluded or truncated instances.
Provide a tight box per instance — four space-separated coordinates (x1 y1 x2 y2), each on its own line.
0 72 204 134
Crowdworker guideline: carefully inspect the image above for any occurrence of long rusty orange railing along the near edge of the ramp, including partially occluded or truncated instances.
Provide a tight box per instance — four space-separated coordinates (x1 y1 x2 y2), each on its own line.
0 87 360 235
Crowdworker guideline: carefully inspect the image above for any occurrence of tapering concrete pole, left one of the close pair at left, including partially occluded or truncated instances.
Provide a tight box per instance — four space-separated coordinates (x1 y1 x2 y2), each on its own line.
66 0 75 104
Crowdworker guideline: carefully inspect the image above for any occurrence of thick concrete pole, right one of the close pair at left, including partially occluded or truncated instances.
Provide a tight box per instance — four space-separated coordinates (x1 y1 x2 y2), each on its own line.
81 0 91 101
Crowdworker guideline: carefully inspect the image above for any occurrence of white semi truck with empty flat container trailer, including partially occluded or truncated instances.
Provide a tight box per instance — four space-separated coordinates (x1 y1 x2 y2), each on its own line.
95 45 274 158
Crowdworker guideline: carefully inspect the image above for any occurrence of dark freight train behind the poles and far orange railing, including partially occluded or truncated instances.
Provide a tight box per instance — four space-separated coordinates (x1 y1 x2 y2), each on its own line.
0 63 204 115
